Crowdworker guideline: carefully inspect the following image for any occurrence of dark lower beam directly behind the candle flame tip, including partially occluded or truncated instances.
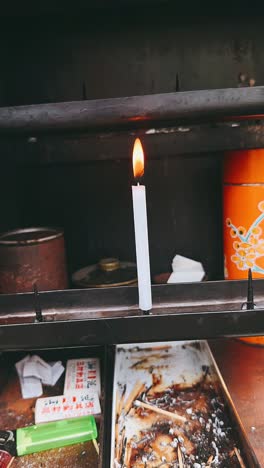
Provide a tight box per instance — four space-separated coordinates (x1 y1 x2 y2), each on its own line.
0 120 264 165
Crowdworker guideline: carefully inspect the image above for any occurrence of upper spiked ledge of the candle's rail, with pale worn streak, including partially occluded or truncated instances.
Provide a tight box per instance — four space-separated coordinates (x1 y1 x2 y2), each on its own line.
0 280 264 325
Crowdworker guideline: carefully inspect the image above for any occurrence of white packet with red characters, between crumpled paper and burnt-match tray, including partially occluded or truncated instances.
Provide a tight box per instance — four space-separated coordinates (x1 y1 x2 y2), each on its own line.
63 358 101 396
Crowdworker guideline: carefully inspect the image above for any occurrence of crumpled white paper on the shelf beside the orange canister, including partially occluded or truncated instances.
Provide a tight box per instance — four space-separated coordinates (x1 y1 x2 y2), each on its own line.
167 255 205 283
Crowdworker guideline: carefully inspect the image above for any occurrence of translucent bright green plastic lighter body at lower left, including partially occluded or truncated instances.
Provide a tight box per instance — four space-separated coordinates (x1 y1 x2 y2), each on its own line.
16 416 97 456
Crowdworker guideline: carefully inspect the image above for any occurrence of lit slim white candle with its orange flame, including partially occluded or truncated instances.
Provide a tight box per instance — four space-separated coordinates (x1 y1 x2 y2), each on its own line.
132 138 152 311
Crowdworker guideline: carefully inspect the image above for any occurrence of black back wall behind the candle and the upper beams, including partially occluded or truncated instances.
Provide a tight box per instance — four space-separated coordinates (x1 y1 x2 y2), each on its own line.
0 1 264 279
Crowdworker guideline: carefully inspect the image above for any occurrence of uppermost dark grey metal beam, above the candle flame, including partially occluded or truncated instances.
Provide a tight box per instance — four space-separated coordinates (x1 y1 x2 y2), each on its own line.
0 87 264 134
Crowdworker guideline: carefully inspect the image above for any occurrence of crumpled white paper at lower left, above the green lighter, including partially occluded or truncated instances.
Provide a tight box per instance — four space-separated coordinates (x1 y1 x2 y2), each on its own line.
15 355 64 398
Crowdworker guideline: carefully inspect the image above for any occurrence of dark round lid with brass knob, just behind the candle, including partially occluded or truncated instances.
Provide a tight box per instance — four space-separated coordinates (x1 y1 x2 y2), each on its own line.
72 258 137 288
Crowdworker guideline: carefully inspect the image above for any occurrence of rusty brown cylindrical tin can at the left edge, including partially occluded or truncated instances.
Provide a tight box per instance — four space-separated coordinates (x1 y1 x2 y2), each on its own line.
0 227 68 294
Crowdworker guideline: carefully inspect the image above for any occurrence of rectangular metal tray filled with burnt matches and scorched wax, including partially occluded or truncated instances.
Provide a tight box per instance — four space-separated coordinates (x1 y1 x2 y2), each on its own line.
110 341 260 468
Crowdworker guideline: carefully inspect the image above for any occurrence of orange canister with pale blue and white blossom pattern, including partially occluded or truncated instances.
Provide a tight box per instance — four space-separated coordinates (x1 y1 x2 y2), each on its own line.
223 149 264 344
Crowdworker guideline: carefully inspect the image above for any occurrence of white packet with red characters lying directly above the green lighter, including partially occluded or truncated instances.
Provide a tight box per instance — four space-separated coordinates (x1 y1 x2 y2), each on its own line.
35 391 101 424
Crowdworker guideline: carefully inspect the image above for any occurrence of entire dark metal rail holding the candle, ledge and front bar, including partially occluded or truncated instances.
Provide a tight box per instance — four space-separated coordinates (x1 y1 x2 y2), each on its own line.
0 280 264 350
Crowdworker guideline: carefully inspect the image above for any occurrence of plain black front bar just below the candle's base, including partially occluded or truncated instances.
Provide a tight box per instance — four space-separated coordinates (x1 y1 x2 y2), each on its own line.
0 309 264 350
